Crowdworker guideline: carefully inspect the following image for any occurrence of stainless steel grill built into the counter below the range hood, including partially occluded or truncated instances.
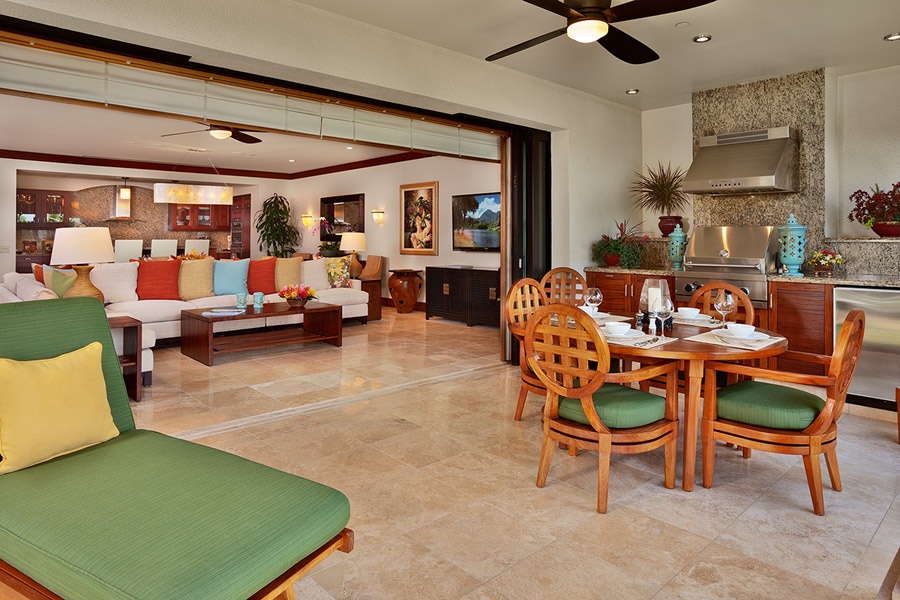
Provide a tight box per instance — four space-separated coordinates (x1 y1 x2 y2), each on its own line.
675 226 778 308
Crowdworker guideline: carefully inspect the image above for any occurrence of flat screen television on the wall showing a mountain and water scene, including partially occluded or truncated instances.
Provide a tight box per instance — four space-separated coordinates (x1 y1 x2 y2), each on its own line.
452 192 500 252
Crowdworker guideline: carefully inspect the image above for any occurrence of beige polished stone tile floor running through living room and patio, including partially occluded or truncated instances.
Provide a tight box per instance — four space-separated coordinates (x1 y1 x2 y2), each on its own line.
133 309 900 600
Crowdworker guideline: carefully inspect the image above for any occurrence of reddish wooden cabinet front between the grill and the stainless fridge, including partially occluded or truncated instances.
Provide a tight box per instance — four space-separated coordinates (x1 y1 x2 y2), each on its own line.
769 281 834 375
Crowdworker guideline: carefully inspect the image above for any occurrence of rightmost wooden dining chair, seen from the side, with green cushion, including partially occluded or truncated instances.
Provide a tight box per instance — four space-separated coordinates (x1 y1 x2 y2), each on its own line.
701 310 866 515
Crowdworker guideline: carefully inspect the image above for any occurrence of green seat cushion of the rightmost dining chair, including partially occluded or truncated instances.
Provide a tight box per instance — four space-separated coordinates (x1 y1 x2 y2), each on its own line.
716 381 825 430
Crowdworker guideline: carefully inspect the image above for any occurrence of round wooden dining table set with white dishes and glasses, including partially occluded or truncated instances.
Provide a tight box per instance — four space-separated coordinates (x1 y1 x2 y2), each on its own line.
607 323 787 492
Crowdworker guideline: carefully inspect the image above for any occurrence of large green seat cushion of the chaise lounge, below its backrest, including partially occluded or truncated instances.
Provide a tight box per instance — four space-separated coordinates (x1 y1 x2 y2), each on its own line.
0 430 350 600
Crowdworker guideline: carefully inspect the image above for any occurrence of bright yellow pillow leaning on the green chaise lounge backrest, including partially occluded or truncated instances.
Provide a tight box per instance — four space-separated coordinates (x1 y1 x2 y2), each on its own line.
0 342 119 474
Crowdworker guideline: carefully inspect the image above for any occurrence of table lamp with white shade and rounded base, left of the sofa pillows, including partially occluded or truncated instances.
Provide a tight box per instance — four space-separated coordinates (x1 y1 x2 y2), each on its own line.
50 227 116 302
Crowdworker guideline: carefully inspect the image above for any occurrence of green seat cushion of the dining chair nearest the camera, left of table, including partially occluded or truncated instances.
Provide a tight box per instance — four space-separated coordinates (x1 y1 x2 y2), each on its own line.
559 384 666 429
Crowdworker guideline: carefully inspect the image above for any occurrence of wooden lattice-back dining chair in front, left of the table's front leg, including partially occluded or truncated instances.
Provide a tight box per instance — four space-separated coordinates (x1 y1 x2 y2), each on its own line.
525 304 678 513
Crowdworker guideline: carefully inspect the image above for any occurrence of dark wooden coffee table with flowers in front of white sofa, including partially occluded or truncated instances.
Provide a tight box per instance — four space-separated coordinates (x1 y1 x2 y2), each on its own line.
181 302 343 366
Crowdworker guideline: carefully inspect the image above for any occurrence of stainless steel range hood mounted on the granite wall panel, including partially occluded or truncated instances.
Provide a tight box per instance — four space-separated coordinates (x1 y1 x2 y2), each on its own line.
684 127 799 196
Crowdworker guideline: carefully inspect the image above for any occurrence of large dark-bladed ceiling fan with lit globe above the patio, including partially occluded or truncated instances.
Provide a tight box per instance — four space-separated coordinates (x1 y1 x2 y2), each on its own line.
485 0 715 65
